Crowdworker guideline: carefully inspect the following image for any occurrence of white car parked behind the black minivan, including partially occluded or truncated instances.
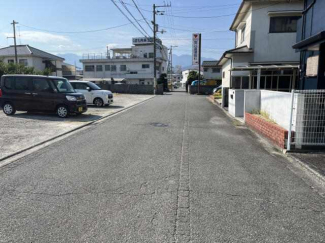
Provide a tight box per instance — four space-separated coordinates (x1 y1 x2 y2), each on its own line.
70 81 113 107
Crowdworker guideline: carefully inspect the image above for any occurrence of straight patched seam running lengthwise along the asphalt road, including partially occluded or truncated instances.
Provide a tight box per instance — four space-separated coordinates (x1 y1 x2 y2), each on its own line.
174 98 191 242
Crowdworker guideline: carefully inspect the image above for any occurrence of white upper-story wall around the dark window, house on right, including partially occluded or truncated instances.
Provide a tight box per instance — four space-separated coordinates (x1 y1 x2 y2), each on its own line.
250 3 303 62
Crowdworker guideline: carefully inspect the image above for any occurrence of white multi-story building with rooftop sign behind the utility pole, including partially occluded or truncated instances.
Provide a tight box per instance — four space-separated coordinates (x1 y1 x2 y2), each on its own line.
80 37 167 85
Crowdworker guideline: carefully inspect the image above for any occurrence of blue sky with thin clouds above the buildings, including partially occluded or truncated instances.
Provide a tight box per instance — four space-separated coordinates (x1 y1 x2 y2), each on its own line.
0 0 241 59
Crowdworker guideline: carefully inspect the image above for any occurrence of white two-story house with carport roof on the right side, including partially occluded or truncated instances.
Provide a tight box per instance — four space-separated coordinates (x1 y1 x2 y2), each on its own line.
218 0 303 91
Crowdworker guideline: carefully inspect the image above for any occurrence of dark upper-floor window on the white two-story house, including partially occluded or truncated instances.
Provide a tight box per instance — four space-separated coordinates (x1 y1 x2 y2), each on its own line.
270 16 300 33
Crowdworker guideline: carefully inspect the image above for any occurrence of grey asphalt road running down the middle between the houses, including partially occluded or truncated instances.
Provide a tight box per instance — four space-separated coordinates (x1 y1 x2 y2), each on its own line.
0 92 325 243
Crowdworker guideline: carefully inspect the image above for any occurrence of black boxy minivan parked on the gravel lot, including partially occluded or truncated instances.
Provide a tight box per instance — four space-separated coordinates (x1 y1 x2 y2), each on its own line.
0 75 87 118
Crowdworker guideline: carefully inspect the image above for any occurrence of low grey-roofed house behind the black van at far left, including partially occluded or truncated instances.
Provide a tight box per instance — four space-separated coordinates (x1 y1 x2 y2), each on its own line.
0 45 64 76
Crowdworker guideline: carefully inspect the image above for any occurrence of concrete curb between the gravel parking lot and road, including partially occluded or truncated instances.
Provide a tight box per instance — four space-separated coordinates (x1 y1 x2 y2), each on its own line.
0 96 156 163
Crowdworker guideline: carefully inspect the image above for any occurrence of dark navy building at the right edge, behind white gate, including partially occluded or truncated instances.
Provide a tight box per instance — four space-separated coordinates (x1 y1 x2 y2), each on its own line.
293 0 325 89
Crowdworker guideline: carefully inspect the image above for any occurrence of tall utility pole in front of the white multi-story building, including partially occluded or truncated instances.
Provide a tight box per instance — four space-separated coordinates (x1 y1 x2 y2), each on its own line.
152 4 171 94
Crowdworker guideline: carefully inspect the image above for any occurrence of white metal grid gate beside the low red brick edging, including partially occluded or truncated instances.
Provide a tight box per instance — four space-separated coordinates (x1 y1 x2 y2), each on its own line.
287 90 325 150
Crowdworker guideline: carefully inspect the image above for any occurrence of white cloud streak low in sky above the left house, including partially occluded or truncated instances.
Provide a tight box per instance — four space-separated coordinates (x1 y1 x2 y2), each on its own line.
4 31 72 44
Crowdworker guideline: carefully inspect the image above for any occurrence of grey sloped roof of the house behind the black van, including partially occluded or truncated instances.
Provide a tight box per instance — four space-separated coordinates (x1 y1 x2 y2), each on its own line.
0 45 65 61
